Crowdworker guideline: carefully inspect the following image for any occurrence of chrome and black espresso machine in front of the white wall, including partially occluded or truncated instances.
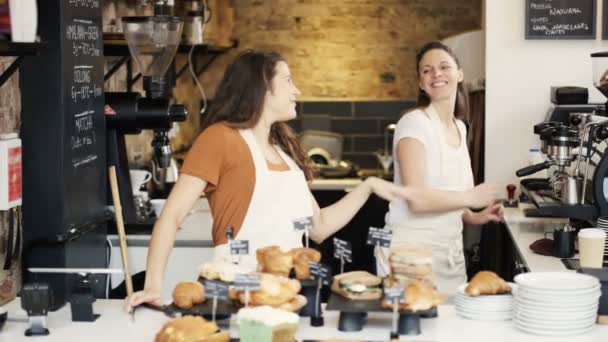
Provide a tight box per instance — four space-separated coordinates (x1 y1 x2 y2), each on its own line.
516 52 608 221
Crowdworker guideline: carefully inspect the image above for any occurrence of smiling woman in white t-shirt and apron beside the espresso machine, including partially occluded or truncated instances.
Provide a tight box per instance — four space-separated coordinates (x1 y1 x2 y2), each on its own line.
377 42 503 292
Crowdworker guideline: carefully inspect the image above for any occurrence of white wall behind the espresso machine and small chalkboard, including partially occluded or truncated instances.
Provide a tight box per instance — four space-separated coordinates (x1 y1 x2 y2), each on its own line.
485 0 608 190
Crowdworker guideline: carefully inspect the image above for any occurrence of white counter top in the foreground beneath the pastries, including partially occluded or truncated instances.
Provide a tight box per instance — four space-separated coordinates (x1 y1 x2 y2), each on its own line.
0 299 608 342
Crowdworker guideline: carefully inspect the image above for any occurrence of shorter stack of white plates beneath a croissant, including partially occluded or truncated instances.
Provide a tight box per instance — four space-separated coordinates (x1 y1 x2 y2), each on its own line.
454 283 517 321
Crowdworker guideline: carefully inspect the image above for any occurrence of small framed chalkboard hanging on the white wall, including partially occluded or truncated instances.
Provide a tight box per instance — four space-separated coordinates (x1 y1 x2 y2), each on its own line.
525 0 597 39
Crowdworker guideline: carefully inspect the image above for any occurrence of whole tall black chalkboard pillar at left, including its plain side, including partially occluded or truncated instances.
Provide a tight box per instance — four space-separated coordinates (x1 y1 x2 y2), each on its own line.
19 0 108 309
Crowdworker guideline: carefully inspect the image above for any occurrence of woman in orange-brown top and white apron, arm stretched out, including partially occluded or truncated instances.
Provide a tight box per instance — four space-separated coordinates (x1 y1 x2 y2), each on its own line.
127 51 414 310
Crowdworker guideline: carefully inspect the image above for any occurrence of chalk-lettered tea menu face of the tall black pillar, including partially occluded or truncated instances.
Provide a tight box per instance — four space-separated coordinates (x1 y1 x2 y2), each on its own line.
60 0 107 227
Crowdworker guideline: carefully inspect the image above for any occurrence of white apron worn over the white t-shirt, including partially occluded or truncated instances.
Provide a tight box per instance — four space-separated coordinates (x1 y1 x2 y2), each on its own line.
376 105 474 293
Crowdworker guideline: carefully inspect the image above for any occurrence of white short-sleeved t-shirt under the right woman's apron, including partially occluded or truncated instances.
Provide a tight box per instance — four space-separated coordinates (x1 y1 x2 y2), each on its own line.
385 109 466 225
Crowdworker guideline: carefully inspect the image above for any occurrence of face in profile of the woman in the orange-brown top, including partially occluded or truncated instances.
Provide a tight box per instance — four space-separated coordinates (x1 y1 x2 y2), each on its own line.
264 61 300 122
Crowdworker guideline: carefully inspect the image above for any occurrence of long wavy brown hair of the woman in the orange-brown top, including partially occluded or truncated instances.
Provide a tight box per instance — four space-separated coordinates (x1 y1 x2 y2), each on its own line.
201 50 313 180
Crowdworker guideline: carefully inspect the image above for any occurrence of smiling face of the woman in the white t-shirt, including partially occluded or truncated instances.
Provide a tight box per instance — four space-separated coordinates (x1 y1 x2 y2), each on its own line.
418 49 463 102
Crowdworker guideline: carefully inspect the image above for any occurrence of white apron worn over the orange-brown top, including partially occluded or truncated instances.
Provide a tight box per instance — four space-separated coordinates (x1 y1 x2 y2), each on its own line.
213 129 313 269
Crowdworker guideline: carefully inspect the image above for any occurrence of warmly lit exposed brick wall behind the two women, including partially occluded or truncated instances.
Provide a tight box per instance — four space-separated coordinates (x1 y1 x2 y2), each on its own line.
202 0 481 99
